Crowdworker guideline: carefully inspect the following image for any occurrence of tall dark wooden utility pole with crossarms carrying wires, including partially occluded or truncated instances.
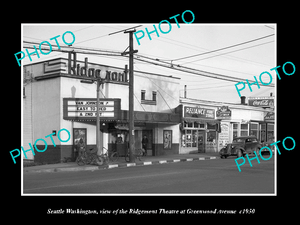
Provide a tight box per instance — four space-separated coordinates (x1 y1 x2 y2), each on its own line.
121 29 138 162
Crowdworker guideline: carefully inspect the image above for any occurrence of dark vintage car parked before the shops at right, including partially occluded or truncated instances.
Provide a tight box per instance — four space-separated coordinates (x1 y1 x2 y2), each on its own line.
219 136 268 158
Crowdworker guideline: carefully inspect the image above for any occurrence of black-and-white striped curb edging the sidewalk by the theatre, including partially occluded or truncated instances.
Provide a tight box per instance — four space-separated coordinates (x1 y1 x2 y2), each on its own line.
23 156 218 173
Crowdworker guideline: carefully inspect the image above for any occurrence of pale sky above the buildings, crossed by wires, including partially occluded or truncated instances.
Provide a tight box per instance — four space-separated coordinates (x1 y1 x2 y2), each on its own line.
21 21 277 103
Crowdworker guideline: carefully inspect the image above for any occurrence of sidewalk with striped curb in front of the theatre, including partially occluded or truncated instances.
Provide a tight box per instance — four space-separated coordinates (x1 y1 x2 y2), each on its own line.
23 153 219 173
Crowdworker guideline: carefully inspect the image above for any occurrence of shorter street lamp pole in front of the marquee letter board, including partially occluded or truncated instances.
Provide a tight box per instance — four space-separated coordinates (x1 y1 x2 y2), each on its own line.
80 70 106 161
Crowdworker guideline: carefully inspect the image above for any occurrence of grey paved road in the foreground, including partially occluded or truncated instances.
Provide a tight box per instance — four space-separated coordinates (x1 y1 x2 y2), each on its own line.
23 158 274 194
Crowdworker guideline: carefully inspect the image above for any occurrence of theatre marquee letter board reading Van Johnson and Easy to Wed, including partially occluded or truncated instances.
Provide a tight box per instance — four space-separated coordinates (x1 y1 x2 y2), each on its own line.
63 98 121 120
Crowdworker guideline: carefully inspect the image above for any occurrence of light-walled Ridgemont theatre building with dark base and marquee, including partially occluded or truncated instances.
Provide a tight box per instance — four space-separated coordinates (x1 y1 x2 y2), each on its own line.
22 53 181 162
